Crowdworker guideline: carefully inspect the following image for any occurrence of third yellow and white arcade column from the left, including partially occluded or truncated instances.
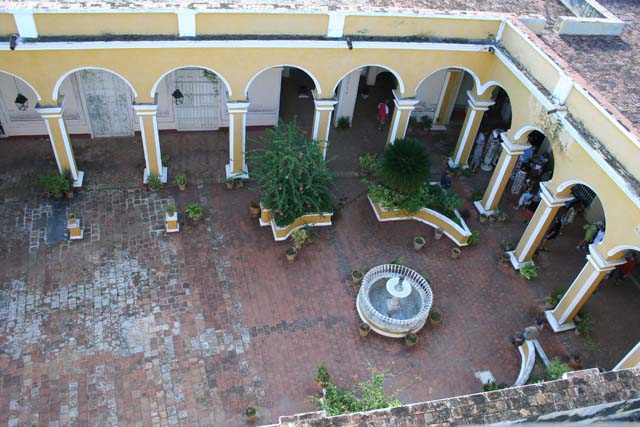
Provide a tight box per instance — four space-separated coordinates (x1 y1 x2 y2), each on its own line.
226 100 249 179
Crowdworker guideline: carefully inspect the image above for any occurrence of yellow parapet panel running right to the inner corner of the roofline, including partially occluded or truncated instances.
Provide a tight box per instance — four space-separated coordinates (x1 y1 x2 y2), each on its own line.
344 16 500 39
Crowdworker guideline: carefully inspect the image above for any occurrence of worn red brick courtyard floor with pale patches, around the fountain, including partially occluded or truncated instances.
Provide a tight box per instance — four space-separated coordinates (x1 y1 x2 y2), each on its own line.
0 113 640 426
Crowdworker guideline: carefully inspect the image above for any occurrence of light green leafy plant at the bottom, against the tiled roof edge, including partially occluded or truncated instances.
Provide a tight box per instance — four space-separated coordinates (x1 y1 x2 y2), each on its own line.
314 368 402 416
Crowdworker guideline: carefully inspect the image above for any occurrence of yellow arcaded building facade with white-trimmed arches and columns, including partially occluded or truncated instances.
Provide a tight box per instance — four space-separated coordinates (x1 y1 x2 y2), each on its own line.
0 9 640 368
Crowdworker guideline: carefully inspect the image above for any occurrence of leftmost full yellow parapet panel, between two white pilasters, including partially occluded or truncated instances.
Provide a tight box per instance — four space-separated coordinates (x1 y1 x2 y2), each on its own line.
33 13 178 36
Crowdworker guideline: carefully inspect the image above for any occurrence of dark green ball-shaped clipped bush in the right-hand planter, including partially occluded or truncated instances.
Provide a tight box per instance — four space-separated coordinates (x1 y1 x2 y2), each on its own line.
377 139 431 194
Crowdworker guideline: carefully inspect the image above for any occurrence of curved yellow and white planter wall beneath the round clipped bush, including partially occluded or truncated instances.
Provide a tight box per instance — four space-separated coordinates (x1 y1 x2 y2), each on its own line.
367 196 471 246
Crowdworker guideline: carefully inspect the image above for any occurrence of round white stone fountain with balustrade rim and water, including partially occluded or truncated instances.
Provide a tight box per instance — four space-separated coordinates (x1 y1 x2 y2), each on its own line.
356 264 433 338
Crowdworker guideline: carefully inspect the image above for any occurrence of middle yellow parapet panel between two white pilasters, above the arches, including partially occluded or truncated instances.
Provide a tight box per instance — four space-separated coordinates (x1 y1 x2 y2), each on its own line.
196 13 329 36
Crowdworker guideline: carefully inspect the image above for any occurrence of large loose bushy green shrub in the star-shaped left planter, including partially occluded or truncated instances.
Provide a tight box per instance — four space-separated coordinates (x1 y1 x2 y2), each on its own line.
251 119 333 226
